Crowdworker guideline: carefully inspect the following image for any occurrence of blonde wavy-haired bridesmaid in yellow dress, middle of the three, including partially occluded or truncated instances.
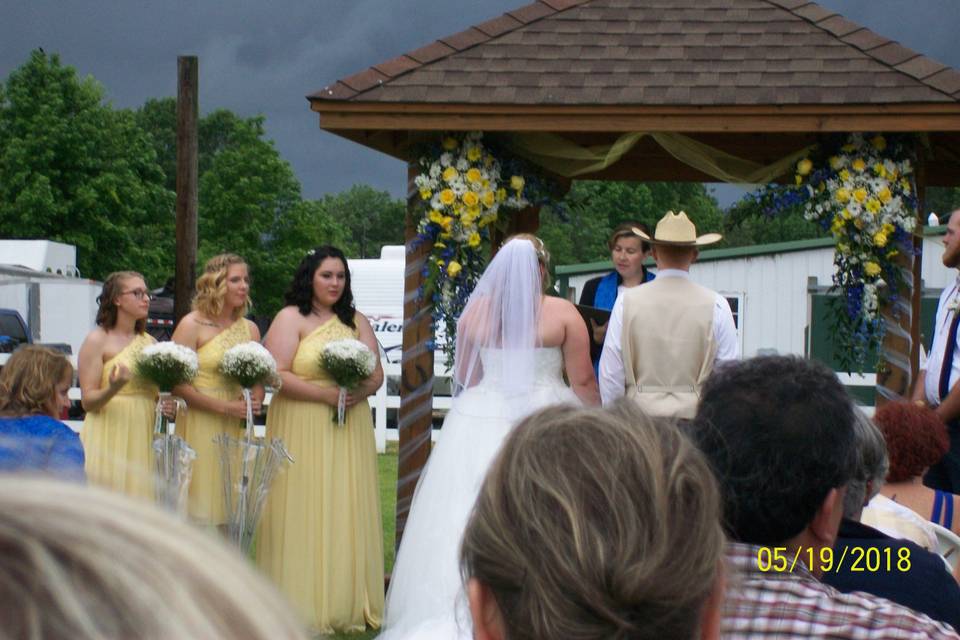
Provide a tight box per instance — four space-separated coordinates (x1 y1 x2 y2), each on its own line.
173 253 264 526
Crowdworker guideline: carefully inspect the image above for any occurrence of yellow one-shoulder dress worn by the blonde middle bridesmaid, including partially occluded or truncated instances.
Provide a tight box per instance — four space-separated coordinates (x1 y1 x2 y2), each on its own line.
177 318 251 525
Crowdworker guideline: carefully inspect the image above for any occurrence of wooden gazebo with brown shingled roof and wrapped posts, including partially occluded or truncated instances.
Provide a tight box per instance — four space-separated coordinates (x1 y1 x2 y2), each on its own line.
308 0 960 542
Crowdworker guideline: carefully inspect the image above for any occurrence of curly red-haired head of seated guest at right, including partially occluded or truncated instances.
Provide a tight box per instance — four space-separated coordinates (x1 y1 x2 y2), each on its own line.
873 402 950 482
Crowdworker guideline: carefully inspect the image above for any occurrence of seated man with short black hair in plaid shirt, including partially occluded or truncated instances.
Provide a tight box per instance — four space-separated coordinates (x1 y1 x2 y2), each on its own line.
690 356 960 639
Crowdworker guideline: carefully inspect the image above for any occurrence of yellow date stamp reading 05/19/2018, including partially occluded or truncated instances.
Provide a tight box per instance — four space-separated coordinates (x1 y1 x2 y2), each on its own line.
757 547 911 573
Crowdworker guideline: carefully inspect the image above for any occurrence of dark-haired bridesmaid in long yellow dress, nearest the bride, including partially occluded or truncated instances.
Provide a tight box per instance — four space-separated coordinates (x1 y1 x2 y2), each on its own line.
257 246 384 634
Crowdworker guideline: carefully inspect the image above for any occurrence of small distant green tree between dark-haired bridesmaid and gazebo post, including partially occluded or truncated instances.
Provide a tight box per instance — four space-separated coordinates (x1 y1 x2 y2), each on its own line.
320 184 406 258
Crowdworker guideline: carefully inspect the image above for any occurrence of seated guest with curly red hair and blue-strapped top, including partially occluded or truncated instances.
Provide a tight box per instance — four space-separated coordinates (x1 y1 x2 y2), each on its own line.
873 402 960 534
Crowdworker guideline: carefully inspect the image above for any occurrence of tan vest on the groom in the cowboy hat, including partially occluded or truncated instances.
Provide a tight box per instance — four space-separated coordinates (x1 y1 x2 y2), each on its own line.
621 277 717 418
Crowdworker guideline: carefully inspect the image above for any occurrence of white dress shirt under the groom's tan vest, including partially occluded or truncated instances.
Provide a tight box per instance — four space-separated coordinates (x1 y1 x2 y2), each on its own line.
599 269 740 405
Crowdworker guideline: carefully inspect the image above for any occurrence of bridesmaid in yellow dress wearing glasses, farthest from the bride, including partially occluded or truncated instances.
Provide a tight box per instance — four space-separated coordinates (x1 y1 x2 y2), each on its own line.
78 271 157 500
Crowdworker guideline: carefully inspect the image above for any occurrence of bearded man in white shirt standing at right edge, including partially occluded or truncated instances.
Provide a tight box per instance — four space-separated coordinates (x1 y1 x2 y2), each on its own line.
913 209 960 493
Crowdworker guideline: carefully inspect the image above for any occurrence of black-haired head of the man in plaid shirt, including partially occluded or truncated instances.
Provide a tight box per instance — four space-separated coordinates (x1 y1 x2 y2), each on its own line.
692 356 856 545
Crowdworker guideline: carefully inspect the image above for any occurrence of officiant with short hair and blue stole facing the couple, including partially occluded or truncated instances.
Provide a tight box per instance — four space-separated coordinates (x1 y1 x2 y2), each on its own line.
580 222 656 374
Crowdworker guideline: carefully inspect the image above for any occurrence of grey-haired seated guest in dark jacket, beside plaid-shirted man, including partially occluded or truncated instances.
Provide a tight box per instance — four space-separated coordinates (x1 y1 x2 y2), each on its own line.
823 410 960 628
